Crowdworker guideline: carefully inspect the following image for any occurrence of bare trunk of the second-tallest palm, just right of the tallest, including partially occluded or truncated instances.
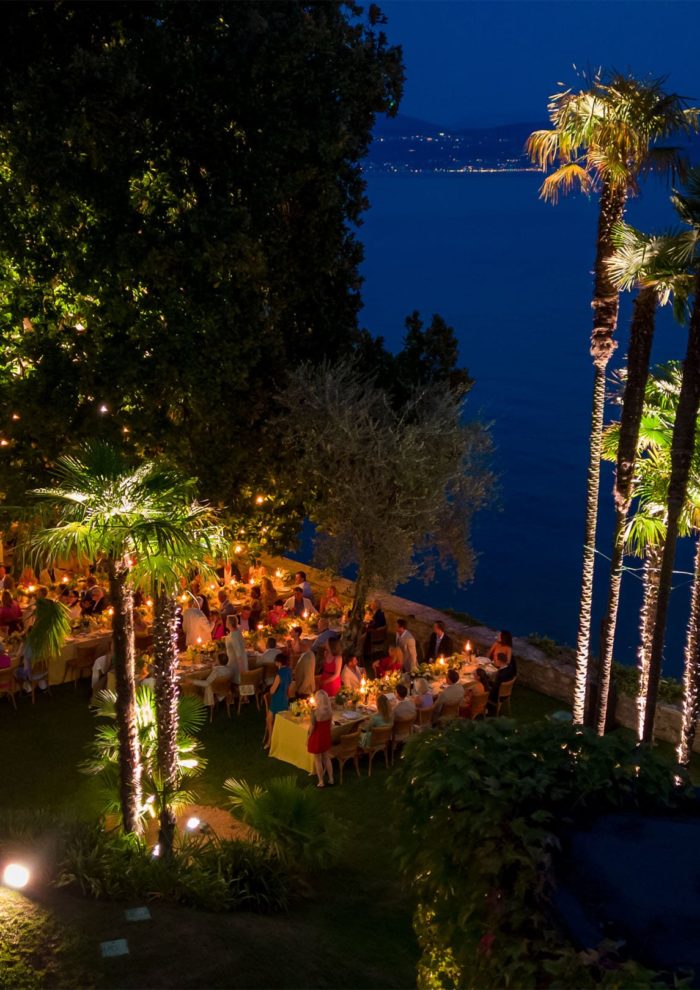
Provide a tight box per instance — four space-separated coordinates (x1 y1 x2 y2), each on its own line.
596 289 656 736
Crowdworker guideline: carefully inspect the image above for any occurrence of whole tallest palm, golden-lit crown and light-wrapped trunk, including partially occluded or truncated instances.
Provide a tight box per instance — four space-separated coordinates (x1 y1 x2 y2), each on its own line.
527 74 698 722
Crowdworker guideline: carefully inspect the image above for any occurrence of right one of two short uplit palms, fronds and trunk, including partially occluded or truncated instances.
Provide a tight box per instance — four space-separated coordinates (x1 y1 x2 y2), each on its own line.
126 488 224 856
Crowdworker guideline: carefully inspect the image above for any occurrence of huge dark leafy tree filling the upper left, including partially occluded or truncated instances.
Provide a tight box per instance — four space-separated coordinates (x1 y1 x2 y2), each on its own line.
0 0 402 544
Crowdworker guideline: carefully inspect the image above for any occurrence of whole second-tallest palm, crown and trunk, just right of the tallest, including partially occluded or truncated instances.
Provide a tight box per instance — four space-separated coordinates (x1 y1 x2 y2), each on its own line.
596 224 692 735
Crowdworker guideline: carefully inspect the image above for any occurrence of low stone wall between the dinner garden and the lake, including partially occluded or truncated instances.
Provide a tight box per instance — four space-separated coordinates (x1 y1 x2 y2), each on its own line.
270 557 700 753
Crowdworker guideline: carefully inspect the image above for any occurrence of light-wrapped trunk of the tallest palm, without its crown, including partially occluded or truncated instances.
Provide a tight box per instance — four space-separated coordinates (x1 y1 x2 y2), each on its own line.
573 183 627 722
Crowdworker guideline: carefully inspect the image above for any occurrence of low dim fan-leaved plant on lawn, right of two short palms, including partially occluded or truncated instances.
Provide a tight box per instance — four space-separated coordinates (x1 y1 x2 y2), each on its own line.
224 777 343 868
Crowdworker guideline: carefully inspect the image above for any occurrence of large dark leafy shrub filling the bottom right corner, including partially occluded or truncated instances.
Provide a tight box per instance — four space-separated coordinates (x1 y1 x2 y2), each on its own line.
391 719 689 990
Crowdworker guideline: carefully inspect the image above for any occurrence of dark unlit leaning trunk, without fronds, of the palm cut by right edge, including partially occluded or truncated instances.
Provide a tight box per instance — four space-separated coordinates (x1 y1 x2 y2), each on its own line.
642 270 700 743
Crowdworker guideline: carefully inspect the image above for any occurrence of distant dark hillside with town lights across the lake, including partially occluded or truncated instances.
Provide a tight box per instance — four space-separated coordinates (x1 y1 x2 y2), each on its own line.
365 114 700 173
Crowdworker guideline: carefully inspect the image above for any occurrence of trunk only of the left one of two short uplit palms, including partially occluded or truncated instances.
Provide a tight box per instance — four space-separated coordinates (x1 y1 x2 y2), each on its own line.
107 560 143 832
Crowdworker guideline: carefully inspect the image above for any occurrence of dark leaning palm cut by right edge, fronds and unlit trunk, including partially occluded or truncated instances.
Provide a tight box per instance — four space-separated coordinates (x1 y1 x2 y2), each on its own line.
642 168 700 743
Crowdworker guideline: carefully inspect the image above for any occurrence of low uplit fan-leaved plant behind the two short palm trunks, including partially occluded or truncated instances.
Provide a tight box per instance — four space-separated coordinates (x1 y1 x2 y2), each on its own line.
81 685 206 820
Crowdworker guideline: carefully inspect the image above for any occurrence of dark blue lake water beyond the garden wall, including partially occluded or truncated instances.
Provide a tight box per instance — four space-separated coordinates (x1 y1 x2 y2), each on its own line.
360 173 692 675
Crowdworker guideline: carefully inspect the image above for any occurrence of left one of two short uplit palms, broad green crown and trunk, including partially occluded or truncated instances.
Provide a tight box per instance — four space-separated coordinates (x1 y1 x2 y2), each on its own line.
29 443 208 832
